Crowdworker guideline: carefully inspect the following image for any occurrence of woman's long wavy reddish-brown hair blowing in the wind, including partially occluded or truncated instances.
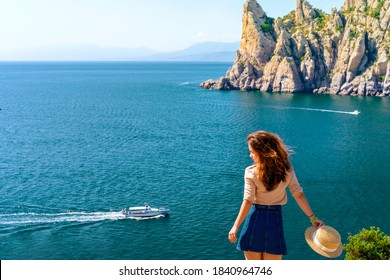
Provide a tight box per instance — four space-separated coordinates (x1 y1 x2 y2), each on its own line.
247 131 291 191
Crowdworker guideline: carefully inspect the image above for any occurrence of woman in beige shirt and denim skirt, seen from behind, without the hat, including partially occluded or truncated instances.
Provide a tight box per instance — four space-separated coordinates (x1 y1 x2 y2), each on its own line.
229 131 324 260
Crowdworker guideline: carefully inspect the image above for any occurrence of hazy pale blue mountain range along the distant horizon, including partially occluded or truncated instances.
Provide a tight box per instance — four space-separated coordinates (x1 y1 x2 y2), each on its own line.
0 42 240 61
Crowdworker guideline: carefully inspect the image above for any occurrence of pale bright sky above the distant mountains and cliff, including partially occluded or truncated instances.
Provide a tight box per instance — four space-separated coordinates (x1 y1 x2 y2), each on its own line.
0 0 344 52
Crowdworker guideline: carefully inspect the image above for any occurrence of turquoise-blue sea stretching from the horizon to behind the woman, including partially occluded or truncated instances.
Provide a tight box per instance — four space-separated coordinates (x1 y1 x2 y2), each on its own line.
0 62 390 260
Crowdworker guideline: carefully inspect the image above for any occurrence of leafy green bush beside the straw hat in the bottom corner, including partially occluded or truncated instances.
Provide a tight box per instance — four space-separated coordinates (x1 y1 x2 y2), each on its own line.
344 226 390 260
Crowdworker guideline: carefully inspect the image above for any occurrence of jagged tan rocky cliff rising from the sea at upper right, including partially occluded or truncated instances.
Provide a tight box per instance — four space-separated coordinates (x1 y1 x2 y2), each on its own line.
201 0 390 96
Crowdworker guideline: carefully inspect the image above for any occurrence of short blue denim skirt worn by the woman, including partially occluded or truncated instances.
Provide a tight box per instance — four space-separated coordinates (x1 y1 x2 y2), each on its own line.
237 204 287 255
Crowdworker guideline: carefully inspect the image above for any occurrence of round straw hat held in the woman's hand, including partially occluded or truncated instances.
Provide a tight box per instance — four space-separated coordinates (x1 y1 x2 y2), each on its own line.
305 226 343 258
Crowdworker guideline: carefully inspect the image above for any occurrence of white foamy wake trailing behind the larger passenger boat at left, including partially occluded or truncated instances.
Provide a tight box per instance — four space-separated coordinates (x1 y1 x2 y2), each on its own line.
0 212 124 225
